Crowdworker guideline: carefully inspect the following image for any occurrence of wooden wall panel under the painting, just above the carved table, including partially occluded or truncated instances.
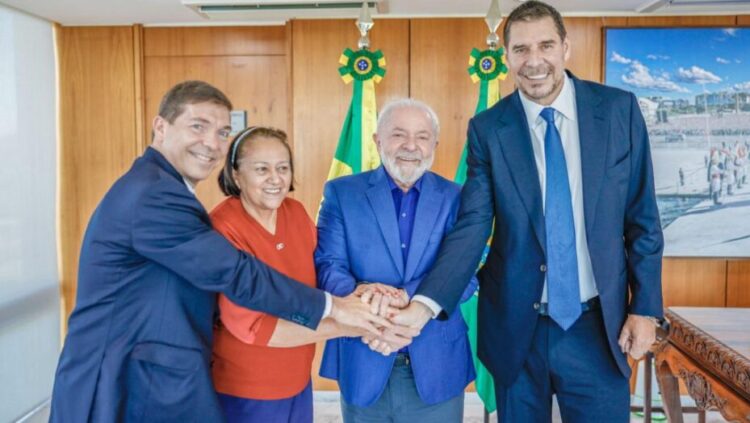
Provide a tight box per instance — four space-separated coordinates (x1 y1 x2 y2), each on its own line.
662 258 727 307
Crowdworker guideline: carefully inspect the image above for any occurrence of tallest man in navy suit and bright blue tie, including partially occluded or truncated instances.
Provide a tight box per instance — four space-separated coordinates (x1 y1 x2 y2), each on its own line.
384 0 663 422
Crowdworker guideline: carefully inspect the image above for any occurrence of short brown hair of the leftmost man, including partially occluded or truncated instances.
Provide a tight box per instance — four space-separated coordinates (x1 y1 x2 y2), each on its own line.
159 81 232 124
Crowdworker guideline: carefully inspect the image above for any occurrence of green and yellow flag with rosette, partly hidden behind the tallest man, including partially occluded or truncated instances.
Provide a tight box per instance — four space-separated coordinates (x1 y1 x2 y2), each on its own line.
454 47 508 413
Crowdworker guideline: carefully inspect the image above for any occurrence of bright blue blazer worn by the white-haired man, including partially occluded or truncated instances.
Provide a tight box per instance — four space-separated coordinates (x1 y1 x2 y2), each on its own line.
315 166 477 407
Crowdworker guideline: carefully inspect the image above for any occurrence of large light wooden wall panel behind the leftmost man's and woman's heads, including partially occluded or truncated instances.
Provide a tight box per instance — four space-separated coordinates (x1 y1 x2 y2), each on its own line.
144 56 288 211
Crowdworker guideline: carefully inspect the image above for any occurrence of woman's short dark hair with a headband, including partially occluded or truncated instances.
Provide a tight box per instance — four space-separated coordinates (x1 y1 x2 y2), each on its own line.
219 126 294 197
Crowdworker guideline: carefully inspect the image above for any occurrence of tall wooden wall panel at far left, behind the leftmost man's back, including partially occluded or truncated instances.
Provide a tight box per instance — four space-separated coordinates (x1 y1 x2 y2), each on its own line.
57 27 137 321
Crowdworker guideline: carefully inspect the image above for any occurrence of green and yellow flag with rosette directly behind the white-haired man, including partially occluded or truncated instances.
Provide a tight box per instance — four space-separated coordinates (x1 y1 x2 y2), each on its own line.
328 48 385 180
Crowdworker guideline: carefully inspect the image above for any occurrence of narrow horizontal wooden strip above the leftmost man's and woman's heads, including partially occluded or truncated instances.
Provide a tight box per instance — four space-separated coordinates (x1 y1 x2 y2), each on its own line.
144 26 286 57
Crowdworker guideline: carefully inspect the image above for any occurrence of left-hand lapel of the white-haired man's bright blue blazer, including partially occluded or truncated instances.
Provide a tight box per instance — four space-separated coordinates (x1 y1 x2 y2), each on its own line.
366 166 406 277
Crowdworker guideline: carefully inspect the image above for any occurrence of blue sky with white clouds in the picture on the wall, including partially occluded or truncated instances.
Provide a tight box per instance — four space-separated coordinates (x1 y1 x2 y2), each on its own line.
605 28 750 100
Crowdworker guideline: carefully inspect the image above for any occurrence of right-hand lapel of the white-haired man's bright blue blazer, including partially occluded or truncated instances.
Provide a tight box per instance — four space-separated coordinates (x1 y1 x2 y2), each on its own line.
404 172 443 281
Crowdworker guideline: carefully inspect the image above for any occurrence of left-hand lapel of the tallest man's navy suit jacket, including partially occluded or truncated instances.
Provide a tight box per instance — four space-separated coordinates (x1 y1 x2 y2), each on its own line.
497 91 547 251
